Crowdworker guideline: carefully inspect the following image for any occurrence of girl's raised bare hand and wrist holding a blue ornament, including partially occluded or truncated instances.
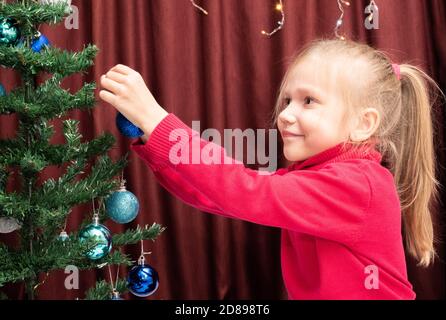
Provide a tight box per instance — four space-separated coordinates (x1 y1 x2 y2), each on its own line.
99 64 169 139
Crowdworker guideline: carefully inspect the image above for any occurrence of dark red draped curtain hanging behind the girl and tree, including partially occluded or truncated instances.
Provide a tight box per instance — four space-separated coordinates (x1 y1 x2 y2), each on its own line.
0 0 446 299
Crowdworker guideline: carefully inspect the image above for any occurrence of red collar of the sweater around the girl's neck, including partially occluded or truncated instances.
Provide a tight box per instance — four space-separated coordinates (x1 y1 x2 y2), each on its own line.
291 143 382 170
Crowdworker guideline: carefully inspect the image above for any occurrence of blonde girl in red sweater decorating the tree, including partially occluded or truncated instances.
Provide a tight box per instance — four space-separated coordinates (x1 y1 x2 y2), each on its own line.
100 40 441 299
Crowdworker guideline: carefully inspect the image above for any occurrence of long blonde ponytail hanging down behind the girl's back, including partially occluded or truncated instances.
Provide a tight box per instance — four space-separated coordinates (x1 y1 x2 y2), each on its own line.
391 64 441 266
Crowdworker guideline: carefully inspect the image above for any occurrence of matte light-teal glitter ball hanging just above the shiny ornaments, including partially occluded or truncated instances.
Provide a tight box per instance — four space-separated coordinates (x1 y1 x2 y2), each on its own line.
105 180 139 224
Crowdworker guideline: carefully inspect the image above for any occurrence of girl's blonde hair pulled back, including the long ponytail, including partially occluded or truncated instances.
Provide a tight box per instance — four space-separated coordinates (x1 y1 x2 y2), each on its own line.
273 39 444 266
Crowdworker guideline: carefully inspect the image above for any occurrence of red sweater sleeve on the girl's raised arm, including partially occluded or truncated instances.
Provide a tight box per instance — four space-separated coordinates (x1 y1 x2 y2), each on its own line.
132 114 371 242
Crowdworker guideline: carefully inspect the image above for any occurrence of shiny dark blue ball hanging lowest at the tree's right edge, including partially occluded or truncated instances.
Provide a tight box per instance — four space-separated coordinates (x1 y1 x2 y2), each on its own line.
127 261 159 298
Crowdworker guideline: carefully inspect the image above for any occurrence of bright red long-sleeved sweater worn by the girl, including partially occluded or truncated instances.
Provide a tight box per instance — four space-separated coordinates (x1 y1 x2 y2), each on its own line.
131 114 415 299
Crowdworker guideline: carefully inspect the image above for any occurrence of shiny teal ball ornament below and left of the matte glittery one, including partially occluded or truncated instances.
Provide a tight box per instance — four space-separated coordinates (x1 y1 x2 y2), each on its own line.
79 214 112 260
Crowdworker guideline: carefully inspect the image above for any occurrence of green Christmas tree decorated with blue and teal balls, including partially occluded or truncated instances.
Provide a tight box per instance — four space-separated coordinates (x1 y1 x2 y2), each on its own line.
0 0 163 299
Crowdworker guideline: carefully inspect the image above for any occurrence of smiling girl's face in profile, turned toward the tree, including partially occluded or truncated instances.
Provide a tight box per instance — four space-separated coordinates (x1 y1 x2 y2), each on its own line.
278 60 350 162
